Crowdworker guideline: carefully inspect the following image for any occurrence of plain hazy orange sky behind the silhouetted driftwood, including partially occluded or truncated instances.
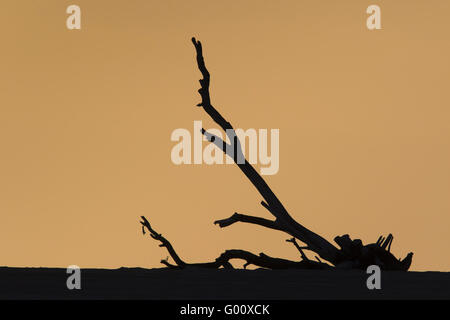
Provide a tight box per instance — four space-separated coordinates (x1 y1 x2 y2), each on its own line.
0 0 450 271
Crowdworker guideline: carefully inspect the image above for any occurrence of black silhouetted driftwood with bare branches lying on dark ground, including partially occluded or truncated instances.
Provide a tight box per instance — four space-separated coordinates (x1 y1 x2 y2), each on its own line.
141 38 413 271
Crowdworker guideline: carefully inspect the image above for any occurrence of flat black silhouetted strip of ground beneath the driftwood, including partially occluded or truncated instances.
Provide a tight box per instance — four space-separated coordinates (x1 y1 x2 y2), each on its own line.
0 267 450 300
